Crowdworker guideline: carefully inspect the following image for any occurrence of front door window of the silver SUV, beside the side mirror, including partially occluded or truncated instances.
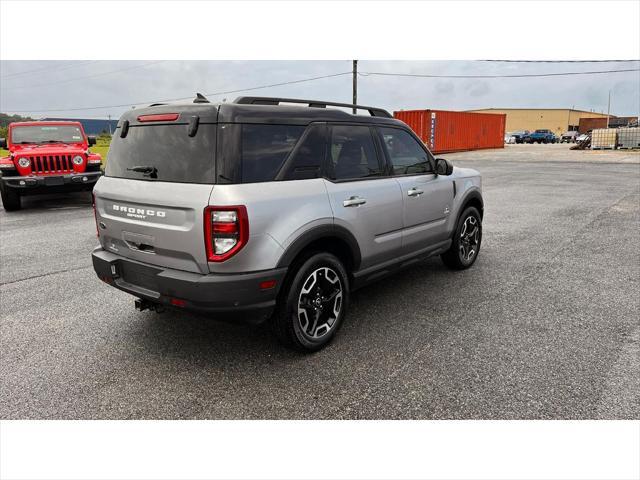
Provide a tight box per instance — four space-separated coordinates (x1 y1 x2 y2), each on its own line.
379 127 433 175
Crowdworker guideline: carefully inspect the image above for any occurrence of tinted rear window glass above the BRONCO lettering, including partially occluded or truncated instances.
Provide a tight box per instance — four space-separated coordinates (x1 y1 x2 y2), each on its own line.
105 124 217 184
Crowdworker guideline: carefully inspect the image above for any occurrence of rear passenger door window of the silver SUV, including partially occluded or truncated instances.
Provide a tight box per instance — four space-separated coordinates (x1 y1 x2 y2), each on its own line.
327 125 384 180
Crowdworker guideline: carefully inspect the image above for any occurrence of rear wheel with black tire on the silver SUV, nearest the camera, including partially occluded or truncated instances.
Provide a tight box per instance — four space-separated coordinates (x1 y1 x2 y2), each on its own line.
271 253 349 352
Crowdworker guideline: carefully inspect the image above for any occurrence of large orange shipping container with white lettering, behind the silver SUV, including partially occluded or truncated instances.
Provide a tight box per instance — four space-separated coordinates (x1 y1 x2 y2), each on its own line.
393 110 507 153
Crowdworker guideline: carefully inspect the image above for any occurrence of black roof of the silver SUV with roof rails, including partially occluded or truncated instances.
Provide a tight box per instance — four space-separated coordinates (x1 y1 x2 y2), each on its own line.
118 97 404 125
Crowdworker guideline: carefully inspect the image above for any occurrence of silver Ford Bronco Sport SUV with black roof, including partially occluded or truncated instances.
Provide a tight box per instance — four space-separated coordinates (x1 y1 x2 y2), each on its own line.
92 95 483 351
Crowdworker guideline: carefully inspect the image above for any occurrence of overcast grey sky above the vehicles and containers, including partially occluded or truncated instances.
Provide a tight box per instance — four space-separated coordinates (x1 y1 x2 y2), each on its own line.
0 60 640 118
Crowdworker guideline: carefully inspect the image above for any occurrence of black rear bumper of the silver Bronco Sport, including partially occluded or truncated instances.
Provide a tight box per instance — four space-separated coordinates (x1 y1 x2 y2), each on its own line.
91 247 287 320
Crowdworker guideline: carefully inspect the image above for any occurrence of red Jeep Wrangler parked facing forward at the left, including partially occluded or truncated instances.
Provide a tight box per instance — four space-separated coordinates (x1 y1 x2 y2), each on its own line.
0 121 102 211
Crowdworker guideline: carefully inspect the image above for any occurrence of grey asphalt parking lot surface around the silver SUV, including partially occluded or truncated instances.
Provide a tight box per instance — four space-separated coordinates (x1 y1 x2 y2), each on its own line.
0 145 640 419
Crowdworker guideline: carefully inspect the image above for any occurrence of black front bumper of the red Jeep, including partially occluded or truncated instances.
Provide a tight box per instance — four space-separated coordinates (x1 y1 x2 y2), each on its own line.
0 171 102 195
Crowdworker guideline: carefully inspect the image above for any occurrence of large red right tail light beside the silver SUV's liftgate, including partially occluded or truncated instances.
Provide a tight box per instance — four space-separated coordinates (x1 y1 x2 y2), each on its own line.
204 205 249 262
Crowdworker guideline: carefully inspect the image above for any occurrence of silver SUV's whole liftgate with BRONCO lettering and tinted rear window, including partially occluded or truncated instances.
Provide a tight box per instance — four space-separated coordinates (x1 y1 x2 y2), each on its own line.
94 116 216 273
